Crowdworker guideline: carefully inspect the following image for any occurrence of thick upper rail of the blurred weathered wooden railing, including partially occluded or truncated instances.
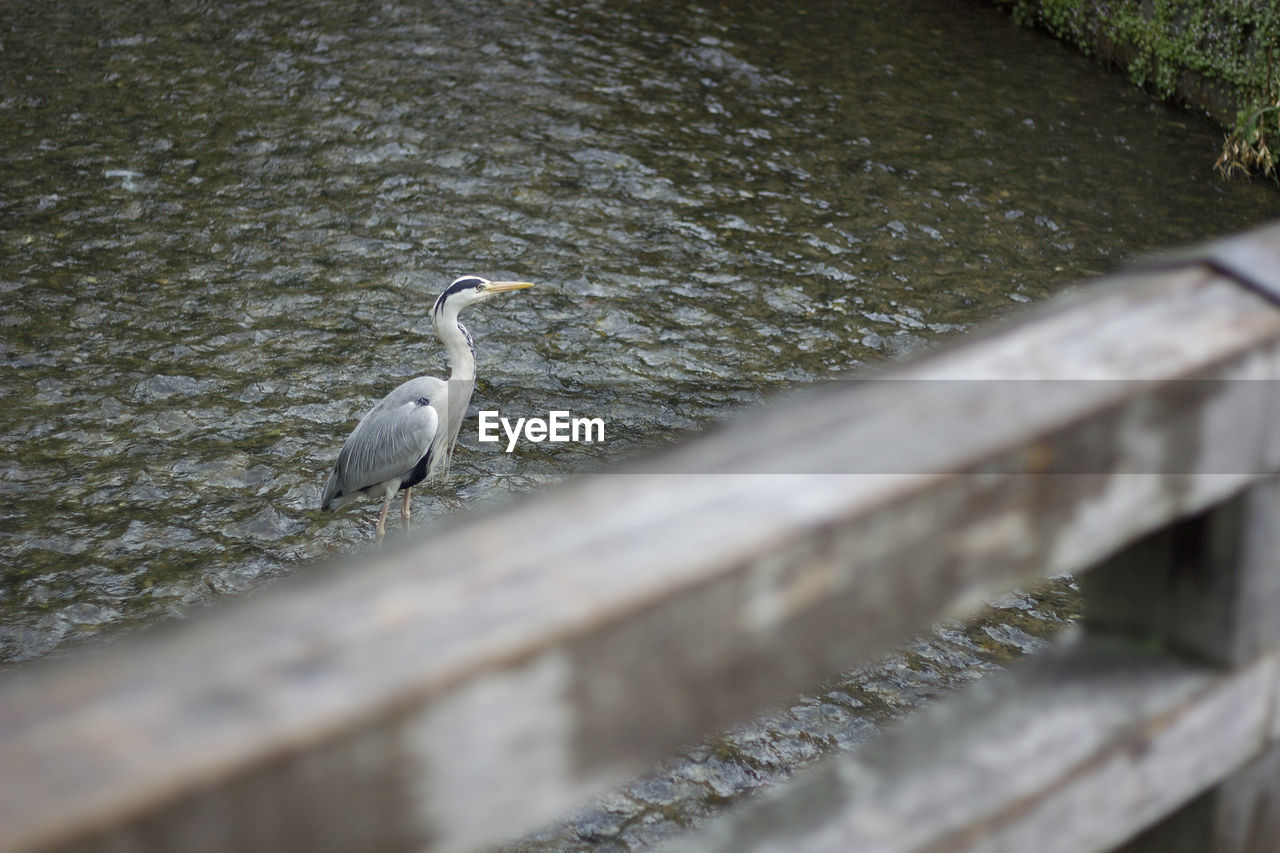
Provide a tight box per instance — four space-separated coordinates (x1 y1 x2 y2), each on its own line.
0 222 1280 850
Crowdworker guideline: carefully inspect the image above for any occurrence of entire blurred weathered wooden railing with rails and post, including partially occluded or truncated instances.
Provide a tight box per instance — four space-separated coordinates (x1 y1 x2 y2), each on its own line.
0 220 1280 853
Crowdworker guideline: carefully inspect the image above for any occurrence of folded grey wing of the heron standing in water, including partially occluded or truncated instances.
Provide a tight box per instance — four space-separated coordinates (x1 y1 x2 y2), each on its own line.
321 380 443 508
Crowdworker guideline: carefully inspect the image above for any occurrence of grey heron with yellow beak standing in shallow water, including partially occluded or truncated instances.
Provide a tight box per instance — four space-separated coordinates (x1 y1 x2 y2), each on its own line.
320 275 532 543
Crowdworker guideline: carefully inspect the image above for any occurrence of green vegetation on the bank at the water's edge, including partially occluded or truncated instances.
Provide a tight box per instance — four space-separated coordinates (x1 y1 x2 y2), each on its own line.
996 0 1280 181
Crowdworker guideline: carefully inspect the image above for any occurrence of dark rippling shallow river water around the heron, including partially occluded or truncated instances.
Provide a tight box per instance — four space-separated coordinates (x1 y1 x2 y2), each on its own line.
0 0 1280 847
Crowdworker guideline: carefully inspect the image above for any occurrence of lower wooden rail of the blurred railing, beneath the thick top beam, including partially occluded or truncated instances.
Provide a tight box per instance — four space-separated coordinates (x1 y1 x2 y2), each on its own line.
664 638 1277 853
